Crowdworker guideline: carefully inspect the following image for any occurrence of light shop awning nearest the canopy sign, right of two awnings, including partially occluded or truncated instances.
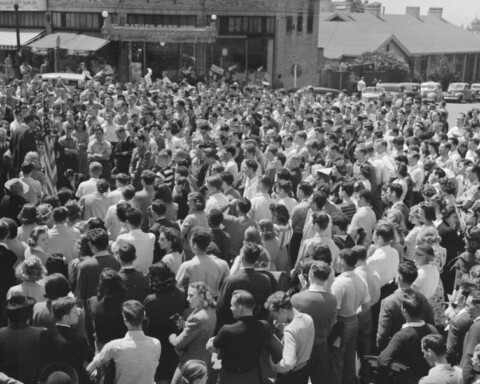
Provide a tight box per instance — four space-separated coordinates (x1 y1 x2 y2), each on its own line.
29 32 108 56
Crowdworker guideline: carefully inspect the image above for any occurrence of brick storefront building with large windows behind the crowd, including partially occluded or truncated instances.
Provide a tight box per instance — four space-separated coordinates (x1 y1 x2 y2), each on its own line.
0 0 330 88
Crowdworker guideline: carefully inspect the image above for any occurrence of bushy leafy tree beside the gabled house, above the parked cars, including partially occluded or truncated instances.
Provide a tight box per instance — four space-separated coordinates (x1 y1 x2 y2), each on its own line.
355 50 410 82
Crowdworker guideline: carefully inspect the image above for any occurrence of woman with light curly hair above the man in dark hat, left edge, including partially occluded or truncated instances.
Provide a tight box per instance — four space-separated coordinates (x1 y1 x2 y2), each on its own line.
7 256 46 303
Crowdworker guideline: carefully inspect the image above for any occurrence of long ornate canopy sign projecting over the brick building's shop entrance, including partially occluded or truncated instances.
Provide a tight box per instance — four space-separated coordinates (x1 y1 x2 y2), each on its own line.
102 21 217 43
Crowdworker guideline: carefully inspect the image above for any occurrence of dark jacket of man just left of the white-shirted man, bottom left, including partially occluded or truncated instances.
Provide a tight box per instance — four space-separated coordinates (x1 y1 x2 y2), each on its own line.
40 325 92 383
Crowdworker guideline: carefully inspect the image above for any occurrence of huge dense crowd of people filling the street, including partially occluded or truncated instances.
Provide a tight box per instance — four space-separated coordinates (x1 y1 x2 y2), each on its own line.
0 67 480 384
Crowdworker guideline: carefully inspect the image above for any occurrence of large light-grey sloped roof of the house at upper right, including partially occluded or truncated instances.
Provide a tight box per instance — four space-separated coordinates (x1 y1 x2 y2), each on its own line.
318 12 480 59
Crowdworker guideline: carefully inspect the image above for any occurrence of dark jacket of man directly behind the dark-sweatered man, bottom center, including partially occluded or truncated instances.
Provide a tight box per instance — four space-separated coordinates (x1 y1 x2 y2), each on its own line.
217 268 272 330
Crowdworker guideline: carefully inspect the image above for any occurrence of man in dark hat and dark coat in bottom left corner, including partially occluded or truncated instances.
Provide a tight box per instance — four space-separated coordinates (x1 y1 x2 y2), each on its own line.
0 295 45 383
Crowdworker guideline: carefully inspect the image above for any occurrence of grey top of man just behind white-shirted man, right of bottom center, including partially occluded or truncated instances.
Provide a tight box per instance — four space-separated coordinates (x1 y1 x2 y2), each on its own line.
292 291 337 345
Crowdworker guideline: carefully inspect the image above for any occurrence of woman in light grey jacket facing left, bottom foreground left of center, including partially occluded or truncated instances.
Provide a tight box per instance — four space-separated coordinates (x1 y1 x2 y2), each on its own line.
168 283 217 384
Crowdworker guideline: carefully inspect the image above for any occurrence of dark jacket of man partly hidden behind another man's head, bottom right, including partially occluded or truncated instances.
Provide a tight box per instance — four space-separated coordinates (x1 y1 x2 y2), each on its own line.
377 289 435 351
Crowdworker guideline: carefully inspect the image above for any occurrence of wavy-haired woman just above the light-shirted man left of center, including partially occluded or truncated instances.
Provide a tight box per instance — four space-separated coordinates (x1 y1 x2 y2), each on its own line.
181 192 210 260
